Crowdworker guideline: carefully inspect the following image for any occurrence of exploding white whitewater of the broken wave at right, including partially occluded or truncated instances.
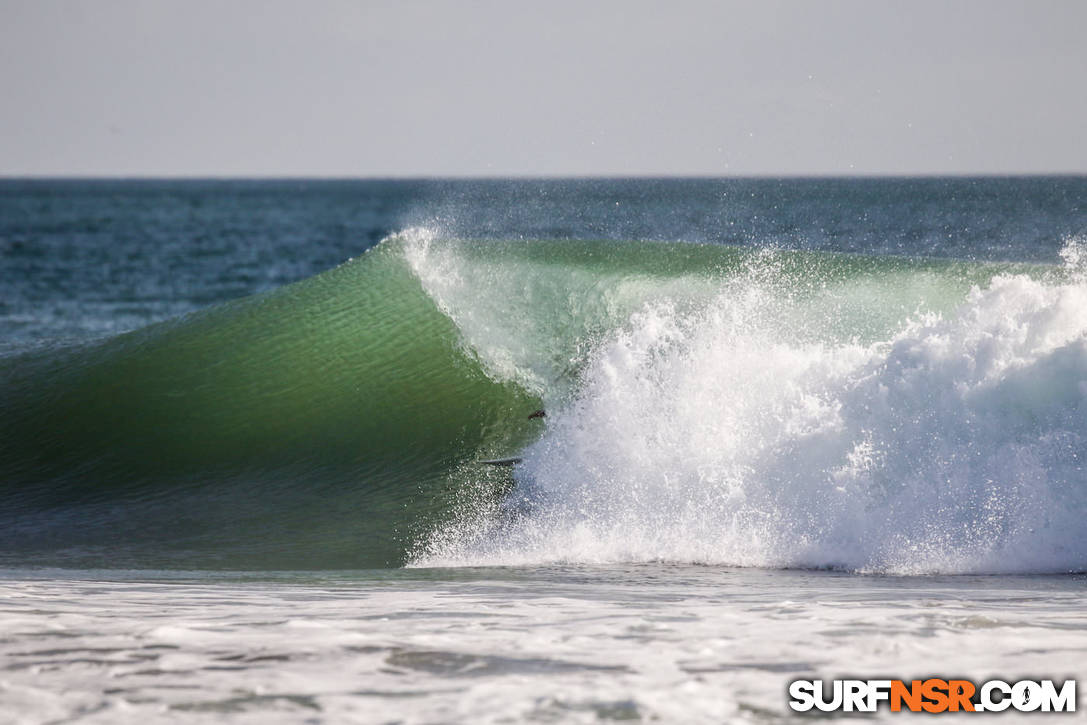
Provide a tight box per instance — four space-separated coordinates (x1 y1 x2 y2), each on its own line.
420 245 1087 573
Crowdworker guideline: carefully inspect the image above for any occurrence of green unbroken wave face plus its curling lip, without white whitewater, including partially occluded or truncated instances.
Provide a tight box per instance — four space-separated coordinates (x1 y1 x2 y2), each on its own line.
0 230 1034 568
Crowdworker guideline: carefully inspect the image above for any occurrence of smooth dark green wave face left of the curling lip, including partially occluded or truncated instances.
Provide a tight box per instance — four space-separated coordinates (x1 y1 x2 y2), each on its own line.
0 235 537 567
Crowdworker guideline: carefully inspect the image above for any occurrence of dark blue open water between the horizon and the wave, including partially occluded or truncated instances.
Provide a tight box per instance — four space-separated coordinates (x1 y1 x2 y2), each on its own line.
0 177 1087 349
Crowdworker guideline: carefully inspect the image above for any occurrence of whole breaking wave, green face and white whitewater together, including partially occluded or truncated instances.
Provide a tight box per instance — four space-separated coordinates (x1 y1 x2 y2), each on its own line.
0 228 1087 573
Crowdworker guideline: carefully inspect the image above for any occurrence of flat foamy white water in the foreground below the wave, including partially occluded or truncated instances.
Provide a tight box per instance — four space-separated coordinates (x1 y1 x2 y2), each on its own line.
0 565 1087 725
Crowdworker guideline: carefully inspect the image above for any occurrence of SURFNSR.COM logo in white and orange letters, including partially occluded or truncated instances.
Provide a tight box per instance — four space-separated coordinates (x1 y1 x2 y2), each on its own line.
789 678 1076 713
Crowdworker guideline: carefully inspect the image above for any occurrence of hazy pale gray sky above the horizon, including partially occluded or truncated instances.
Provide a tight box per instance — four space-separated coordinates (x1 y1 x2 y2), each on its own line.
0 0 1087 176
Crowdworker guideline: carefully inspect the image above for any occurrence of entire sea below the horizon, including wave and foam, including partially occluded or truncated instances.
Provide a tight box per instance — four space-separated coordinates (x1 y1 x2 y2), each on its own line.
0 176 1087 723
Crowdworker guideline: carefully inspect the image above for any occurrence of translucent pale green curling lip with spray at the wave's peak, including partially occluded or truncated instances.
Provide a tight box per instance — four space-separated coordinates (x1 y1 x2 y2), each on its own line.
390 227 726 402
